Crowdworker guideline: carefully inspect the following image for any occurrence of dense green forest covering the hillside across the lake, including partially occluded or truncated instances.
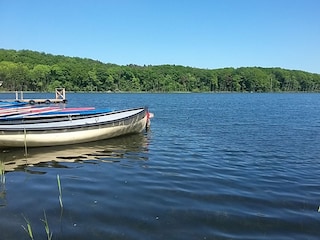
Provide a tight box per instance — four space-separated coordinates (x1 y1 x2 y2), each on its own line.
0 49 320 92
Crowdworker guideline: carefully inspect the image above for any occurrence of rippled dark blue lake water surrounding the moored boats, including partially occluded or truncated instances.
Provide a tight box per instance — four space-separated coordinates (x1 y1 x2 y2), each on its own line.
0 93 320 240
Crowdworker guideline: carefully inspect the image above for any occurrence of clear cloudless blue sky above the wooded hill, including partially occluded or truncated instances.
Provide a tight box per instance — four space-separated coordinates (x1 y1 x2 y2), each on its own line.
0 0 320 73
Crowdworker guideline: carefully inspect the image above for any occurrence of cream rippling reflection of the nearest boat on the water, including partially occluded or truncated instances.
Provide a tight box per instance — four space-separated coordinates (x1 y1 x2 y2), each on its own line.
0 133 148 174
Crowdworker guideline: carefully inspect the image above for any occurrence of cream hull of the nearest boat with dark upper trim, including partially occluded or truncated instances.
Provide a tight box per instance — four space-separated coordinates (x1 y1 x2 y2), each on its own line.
0 108 149 147
